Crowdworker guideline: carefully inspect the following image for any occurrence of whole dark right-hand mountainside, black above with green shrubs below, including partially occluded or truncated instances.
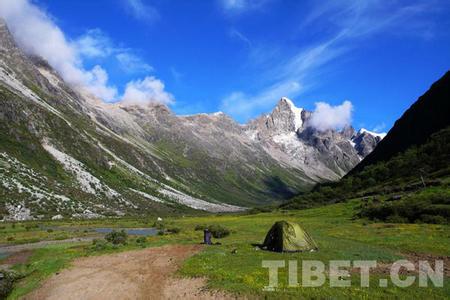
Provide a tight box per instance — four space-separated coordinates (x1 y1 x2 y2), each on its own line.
282 73 450 223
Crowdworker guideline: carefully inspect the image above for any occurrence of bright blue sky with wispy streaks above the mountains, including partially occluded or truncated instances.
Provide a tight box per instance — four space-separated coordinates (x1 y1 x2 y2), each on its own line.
0 0 450 131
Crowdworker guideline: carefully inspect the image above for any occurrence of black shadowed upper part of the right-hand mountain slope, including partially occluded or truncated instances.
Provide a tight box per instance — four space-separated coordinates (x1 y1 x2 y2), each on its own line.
351 71 450 174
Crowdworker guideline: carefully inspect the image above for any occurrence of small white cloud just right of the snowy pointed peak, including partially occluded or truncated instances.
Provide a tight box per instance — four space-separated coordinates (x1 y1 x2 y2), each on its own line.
308 101 353 131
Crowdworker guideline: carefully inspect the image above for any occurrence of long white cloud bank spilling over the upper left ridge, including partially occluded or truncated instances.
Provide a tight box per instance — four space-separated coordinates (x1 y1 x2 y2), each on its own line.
0 0 173 103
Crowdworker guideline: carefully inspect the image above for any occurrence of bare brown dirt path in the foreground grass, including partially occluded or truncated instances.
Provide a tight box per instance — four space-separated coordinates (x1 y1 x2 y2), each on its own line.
25 245 234 300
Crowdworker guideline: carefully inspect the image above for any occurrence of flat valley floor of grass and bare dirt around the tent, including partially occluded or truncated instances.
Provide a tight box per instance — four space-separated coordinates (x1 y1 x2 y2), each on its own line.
0 200 450 299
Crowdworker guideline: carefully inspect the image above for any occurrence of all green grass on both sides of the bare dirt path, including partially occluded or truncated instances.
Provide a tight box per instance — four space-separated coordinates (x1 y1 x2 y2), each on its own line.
4 200 450 299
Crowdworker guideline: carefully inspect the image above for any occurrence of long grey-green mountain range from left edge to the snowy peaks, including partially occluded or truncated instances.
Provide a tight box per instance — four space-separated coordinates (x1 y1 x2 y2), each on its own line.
0 21 382 220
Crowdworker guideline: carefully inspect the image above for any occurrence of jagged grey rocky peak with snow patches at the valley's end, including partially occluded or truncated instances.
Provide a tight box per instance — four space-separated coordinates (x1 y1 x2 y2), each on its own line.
246 97 381 181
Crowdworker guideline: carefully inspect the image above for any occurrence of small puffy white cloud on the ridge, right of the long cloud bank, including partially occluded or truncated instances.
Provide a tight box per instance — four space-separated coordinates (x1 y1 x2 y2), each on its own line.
121 76 174 106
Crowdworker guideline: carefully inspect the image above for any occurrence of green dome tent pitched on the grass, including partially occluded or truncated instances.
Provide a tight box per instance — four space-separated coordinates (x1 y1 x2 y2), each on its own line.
263 221 317 252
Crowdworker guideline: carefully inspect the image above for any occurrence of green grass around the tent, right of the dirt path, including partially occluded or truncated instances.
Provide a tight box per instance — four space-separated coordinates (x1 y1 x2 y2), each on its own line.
175 202 450 299
